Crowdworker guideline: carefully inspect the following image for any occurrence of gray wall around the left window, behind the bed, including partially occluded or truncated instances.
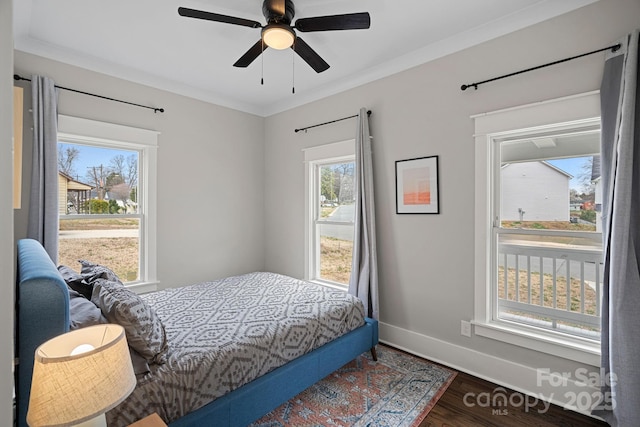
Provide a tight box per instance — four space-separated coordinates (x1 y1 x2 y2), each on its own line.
15 52 264 287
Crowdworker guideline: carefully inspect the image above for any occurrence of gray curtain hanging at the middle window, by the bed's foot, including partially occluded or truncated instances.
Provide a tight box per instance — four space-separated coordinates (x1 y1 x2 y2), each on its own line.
349 108 378 319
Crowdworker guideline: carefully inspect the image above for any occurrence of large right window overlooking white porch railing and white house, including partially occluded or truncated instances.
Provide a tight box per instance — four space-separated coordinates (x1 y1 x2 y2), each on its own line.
474 93 603 364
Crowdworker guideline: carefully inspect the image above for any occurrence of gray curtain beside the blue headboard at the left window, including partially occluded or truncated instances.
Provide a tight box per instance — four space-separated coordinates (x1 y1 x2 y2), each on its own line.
27 76 58 263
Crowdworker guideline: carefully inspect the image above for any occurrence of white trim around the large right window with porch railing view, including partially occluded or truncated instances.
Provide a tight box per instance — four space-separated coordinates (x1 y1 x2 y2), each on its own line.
471 91 600 366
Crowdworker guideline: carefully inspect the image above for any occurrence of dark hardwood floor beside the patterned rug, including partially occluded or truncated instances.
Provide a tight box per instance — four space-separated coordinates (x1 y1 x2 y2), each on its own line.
419 372 608 427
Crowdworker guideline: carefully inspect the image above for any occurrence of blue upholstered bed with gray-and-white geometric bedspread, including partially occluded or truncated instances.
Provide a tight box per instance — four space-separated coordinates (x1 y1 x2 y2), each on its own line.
16 239 378 427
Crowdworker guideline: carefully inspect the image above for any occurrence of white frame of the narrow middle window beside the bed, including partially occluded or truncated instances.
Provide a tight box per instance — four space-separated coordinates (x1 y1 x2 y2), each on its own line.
303 139 357 291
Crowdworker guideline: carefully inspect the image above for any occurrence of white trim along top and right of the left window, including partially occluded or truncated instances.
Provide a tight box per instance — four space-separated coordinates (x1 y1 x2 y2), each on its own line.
58 115 160 293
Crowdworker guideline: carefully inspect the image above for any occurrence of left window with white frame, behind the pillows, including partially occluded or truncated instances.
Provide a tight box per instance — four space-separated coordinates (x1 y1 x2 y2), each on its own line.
58 116 157 291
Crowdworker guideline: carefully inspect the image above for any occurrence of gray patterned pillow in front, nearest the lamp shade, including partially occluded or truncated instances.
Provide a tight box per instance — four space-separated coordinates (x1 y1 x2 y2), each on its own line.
91 279 169 364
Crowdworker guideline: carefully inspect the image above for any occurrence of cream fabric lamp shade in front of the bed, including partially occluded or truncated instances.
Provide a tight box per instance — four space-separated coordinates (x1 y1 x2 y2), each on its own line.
27 324 136 427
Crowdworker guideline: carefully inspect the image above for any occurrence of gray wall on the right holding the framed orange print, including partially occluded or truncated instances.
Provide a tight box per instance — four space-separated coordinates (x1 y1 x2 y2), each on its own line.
265 0 640 406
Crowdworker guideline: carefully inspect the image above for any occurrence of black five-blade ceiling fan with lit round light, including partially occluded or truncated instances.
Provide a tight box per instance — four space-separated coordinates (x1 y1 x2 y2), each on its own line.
178 0 371 73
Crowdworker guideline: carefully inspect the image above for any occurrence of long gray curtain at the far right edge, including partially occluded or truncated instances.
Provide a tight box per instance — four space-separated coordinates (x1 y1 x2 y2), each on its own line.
594 30 640 426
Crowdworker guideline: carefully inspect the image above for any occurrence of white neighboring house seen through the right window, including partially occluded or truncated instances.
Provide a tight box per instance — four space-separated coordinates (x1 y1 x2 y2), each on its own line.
500 161 572 221
